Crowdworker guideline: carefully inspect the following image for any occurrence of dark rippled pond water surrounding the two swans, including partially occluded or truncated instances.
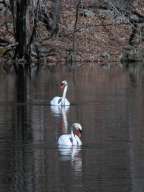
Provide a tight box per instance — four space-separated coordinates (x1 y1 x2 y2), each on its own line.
0 65 144 192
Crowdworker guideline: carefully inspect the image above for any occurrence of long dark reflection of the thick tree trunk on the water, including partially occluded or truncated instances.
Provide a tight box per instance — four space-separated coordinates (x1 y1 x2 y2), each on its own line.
14 71 33 192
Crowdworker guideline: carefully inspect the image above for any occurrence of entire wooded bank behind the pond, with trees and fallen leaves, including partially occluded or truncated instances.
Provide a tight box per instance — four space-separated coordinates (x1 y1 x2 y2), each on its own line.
0 0 144 72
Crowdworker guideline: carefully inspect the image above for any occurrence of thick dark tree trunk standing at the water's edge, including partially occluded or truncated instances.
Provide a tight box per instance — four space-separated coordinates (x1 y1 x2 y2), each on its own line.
10 0 30 72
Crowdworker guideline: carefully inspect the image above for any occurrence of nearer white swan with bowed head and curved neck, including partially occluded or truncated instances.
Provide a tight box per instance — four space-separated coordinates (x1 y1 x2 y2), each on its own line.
58 123 82 147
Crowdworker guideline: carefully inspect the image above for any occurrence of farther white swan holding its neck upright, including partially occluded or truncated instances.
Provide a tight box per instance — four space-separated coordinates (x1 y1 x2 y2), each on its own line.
50 81 70 106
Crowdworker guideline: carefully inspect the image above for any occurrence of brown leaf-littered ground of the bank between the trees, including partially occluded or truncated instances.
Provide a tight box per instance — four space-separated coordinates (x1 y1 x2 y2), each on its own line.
0 0 144 71
